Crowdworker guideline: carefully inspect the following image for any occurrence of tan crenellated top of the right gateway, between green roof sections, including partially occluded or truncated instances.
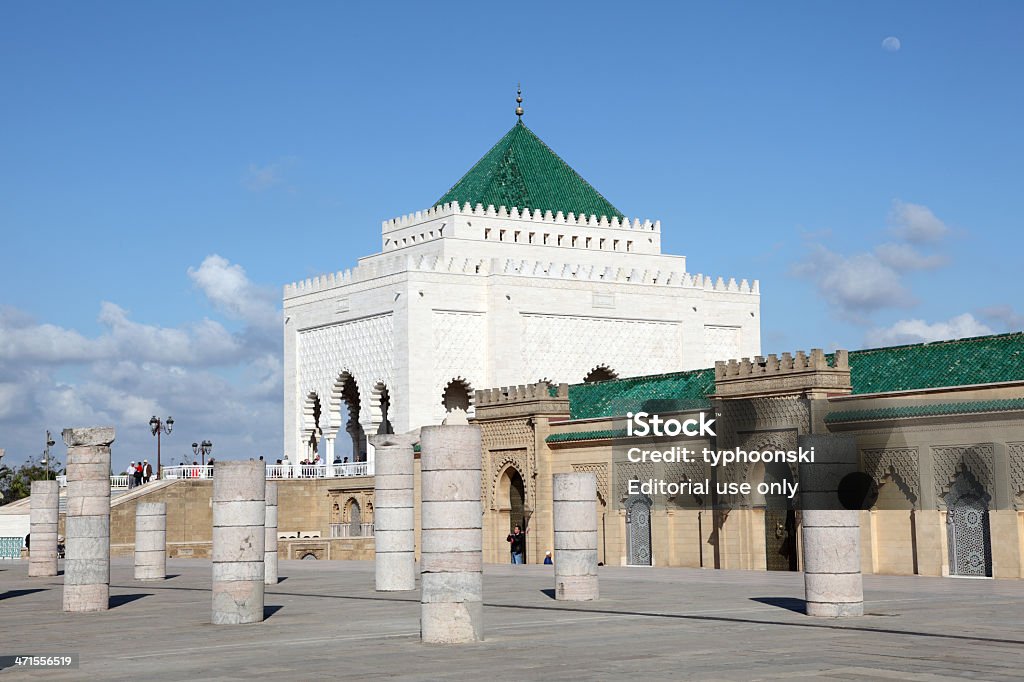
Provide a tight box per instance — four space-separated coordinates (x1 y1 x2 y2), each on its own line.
715 348 852 398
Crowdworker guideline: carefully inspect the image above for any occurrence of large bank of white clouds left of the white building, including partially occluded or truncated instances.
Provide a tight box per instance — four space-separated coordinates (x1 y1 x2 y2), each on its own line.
0 256 284 468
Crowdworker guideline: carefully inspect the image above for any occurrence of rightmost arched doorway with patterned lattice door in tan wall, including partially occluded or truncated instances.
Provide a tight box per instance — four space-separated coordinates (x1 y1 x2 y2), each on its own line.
946 469 992 578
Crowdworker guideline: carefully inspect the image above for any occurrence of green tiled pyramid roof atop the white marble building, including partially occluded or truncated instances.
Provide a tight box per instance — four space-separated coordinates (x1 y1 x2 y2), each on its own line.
436 121 624 218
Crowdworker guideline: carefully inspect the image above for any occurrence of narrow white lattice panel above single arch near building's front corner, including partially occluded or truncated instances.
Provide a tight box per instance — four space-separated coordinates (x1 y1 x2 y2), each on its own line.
431 310 489 406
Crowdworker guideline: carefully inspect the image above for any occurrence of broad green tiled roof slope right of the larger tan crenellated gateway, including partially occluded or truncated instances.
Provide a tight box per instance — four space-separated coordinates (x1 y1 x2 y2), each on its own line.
850 332 1024 393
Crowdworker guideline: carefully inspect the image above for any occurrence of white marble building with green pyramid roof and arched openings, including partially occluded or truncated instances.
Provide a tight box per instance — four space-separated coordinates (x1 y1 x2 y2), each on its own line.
284 121 761 466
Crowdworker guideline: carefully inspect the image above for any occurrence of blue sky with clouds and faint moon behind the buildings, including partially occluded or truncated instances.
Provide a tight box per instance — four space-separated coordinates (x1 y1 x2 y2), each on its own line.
0 2 1024 466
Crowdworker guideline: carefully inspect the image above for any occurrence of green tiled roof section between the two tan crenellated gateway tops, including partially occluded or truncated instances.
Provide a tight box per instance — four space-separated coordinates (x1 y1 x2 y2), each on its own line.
569 370 715 419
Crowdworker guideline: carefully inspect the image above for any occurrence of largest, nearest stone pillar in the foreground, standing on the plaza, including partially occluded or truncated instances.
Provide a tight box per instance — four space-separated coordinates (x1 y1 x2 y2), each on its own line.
420 426 483 644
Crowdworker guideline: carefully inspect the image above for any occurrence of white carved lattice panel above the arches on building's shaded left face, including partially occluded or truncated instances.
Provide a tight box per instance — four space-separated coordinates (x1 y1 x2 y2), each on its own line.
296 313 393 429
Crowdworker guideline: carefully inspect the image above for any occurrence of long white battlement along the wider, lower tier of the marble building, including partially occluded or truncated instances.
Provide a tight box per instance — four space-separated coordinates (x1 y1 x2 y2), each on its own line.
285 254 761 298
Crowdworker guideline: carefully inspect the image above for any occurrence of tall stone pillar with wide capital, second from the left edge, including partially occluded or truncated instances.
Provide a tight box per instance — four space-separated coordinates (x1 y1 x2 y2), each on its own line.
62 427 114 612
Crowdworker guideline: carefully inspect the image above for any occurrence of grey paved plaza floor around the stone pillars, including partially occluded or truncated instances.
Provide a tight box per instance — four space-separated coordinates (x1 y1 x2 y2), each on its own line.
0 559 1024 680
